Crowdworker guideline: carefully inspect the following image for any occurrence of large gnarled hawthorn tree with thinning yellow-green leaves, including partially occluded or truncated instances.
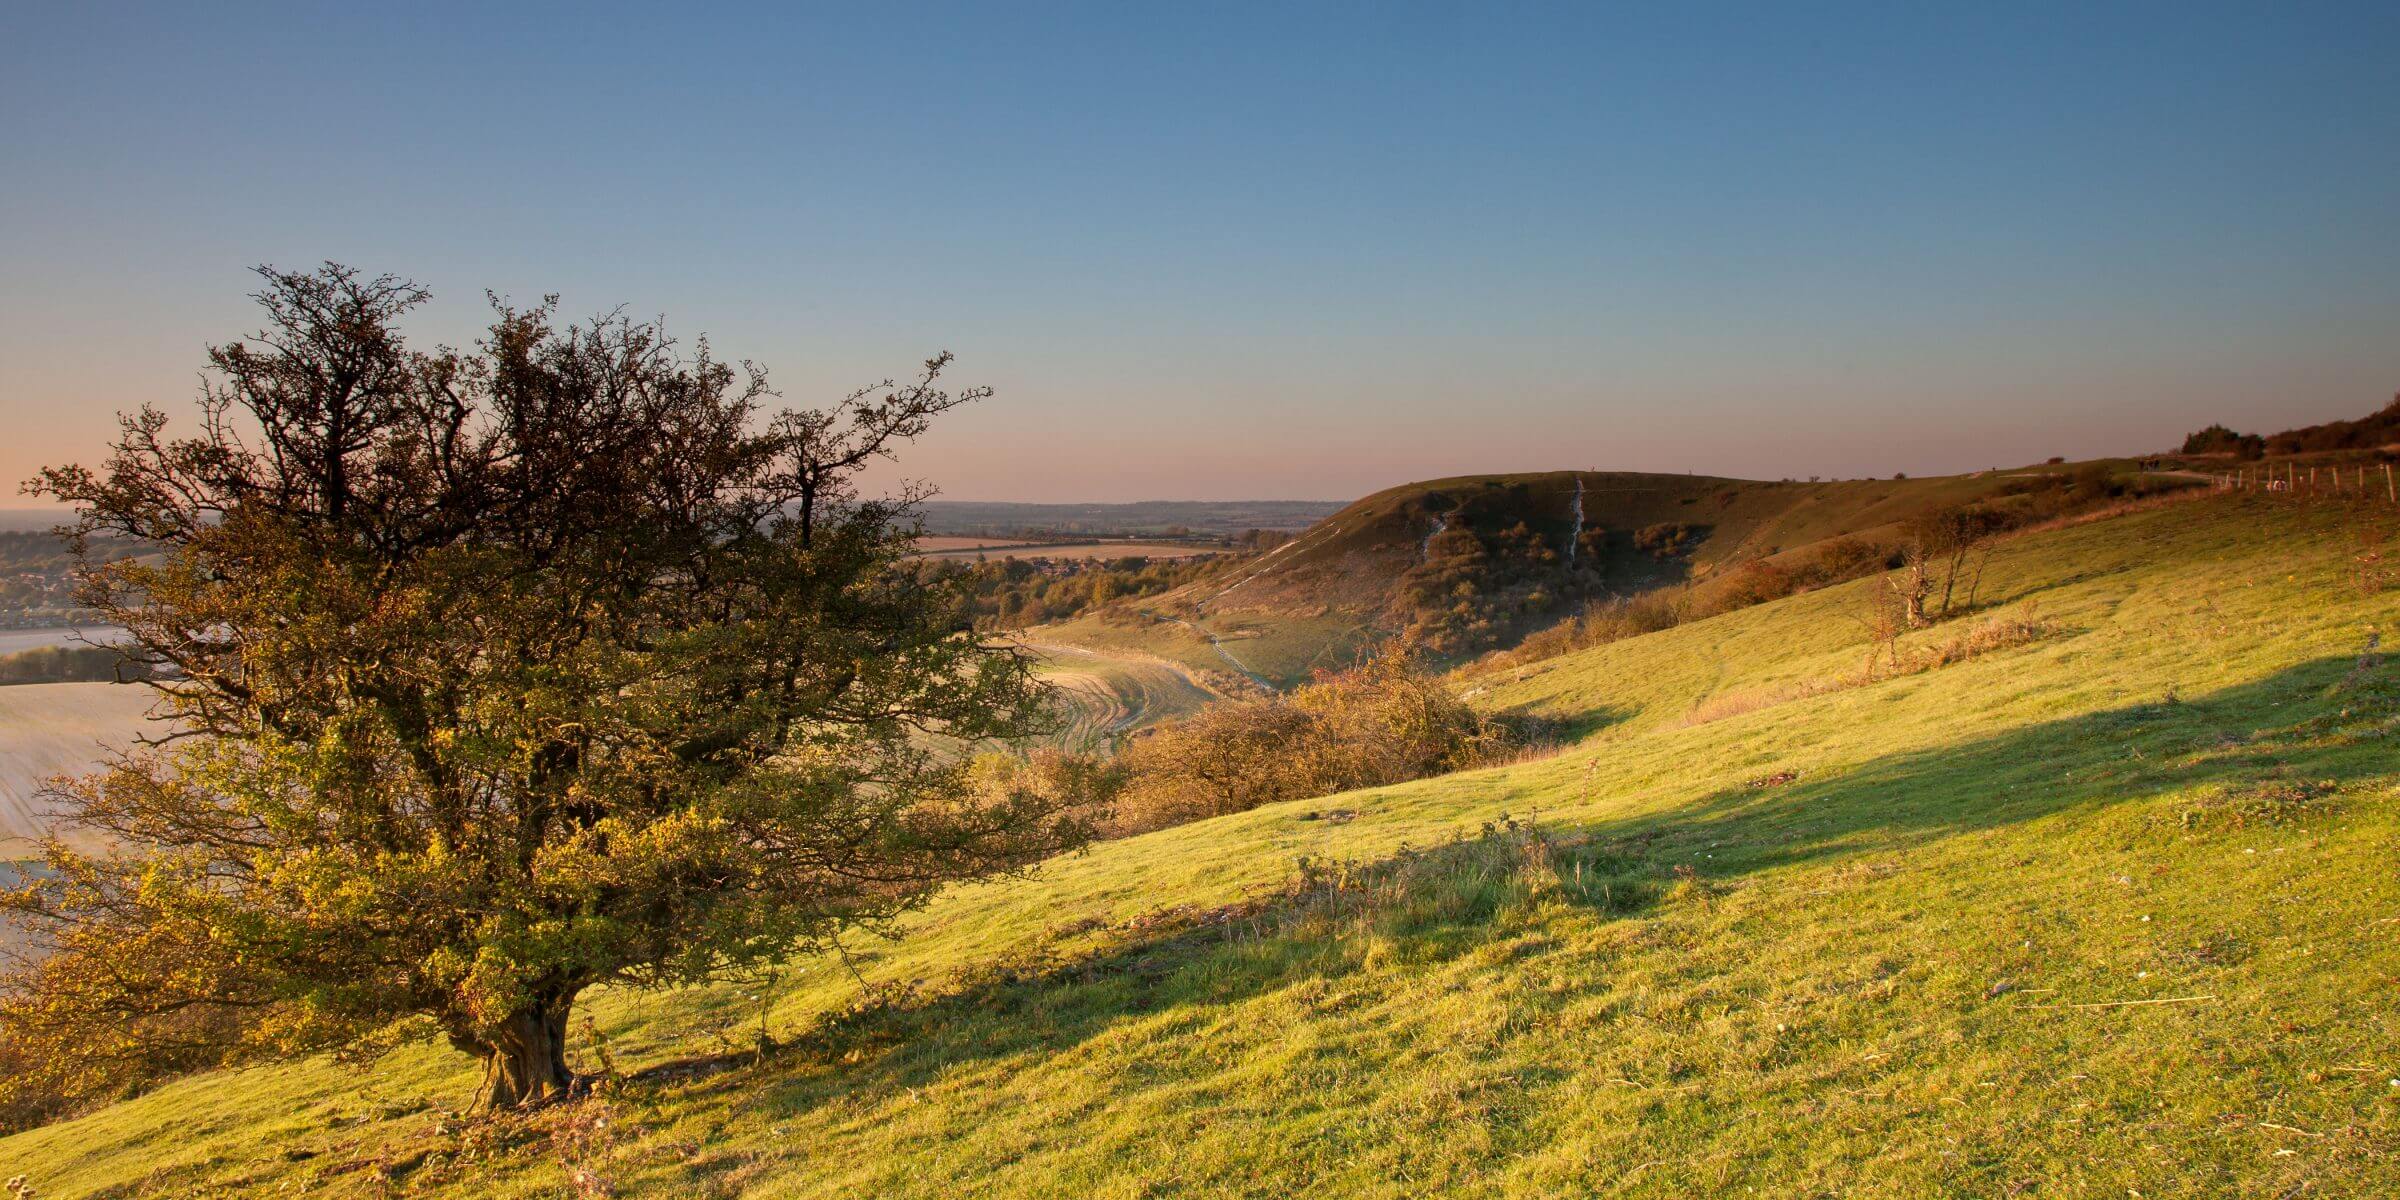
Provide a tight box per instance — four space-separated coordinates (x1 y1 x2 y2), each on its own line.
0 264 1092 1109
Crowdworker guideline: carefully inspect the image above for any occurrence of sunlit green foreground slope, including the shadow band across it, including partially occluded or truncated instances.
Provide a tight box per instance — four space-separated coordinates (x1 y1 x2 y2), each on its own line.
0 499 2400 1198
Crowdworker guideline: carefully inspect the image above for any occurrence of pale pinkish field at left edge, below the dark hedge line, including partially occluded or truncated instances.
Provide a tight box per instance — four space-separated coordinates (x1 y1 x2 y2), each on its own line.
0 684 156 859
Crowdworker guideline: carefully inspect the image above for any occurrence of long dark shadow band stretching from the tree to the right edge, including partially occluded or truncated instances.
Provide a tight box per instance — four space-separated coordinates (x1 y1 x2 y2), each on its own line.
646 660 2400 1114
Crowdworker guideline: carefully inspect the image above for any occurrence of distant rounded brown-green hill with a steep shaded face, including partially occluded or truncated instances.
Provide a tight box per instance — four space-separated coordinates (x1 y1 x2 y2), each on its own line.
1044 461 2160 686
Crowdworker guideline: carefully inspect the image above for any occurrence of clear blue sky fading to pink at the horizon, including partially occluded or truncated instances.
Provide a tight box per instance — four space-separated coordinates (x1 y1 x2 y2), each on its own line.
0 2 2400 499
